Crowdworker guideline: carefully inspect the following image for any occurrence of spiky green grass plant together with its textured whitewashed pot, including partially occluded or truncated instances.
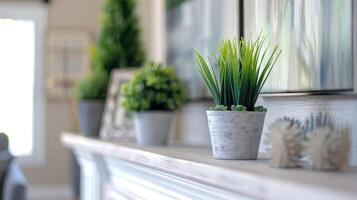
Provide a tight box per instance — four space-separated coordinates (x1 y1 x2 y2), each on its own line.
196 35 281 159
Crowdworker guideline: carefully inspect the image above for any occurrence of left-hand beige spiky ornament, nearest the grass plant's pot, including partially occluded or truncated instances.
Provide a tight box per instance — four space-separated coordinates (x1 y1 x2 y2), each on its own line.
267 117 303 168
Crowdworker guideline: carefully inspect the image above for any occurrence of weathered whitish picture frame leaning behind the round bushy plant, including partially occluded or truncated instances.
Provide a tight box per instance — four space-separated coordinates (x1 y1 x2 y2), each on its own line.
99 69 135 142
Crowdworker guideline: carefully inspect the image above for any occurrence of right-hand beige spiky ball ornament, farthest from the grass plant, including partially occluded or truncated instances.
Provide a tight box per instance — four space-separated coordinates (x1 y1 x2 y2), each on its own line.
306 126 350 170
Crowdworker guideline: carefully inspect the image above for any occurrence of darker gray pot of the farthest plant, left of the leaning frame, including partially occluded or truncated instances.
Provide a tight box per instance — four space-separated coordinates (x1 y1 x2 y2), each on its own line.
77 100 104 137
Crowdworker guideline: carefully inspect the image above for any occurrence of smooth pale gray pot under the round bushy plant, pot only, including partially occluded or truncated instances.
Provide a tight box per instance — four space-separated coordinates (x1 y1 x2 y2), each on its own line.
135 111 174 145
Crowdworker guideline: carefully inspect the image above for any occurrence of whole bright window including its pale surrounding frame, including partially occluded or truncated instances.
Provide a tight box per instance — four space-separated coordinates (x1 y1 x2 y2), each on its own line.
0 3 46 166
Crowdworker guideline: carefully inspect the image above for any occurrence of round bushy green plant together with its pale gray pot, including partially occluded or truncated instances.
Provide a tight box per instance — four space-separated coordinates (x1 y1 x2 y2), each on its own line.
121 64 186 145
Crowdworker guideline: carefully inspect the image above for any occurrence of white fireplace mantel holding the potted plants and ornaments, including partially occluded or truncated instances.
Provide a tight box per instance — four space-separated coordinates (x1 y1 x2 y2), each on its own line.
62 133 357 200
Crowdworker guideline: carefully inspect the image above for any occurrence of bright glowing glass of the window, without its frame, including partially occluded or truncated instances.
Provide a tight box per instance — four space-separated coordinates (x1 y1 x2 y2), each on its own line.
0 19 36 156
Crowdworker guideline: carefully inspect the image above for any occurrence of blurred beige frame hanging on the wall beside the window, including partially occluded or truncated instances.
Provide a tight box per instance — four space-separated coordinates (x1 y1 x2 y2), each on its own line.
45 28 93 101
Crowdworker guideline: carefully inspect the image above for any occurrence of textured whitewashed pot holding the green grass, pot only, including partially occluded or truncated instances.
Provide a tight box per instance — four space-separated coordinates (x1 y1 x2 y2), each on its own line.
207 111 266 160
